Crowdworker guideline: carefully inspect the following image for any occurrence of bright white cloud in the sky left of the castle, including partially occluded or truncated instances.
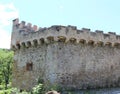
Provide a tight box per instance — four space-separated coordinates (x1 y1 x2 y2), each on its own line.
0 3 19 48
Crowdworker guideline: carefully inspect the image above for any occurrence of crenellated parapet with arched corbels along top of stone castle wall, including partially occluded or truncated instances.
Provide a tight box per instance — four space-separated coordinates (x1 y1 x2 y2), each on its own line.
11 19 120 49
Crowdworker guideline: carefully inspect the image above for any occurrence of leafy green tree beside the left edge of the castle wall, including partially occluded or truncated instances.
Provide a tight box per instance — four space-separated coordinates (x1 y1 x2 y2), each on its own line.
0 49 13 89
